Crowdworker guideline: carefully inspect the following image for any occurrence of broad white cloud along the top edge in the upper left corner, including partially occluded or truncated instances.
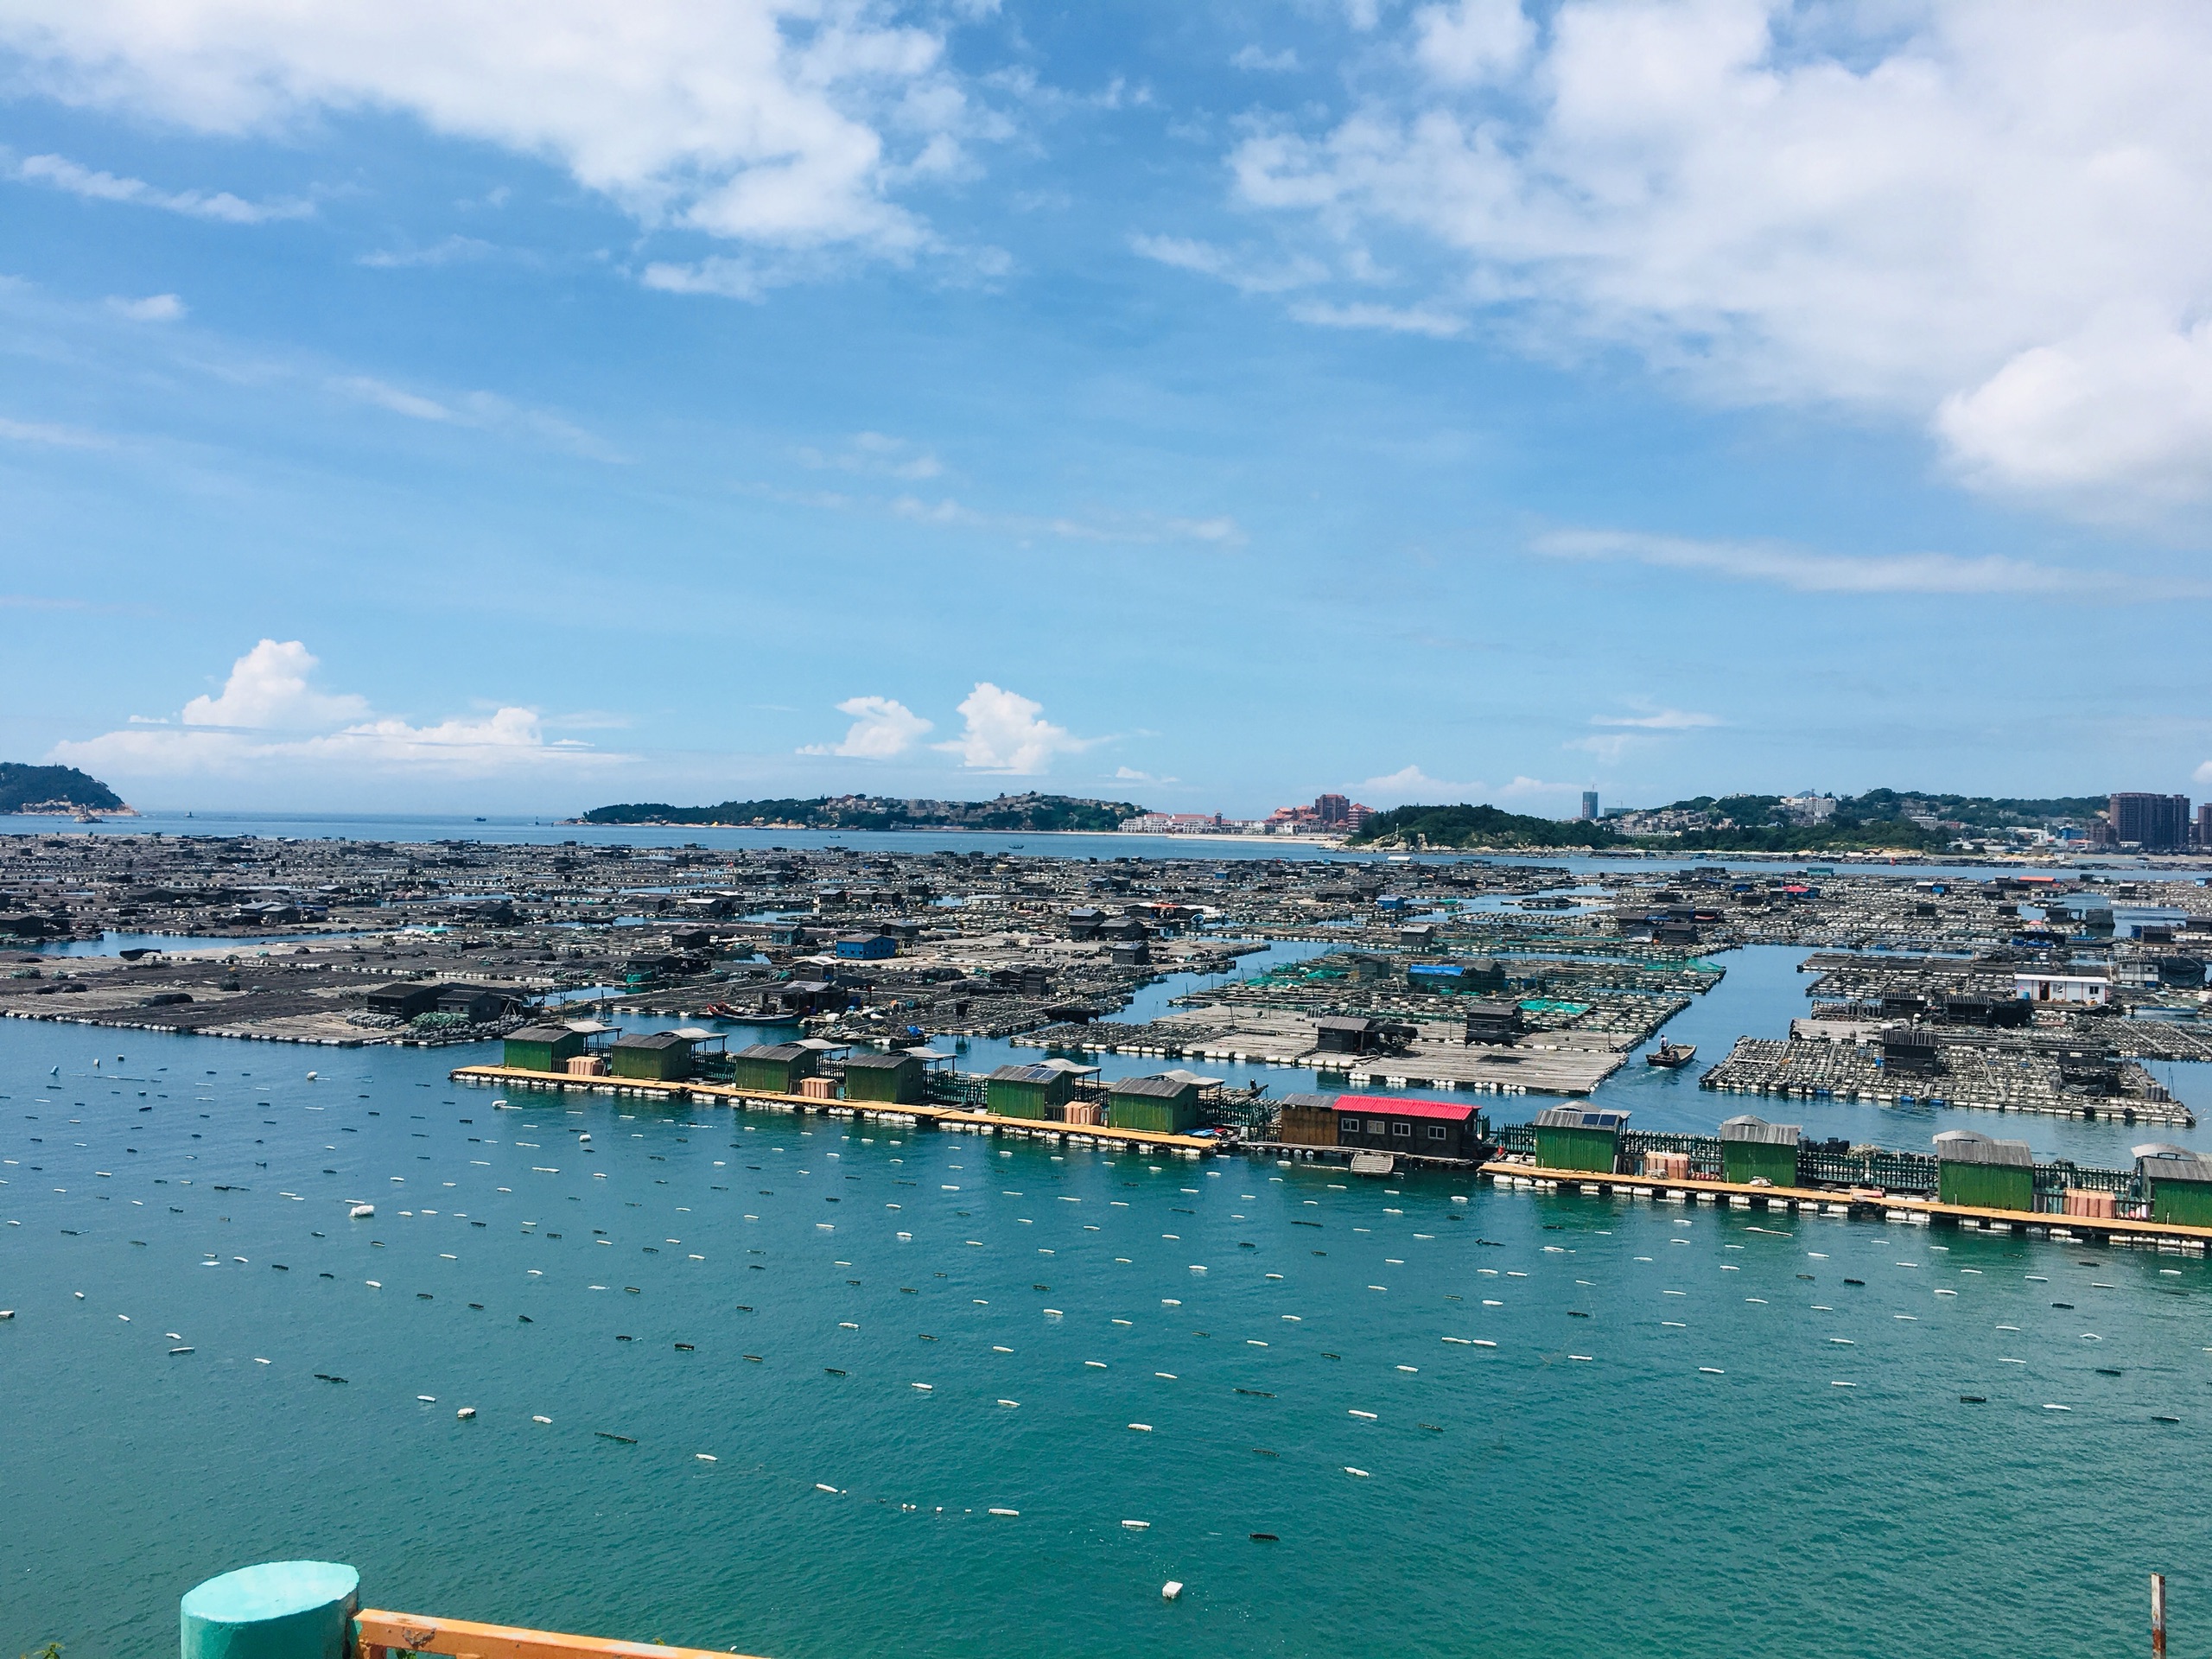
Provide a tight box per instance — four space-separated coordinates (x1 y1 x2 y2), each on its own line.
0 0 988 257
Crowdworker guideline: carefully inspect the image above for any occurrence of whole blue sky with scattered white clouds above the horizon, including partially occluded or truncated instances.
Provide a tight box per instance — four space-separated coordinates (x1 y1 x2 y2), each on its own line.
0 0 2212 817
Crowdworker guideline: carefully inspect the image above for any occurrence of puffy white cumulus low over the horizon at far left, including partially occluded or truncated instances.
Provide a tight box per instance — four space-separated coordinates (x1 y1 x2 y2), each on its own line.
47 639 631 779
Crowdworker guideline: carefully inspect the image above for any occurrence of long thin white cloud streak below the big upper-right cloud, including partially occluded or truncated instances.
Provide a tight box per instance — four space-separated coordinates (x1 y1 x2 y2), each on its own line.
1533 531 2205 600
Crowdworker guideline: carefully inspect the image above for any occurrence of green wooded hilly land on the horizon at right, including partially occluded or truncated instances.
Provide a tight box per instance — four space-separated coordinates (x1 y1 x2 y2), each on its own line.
1344 790 2110 854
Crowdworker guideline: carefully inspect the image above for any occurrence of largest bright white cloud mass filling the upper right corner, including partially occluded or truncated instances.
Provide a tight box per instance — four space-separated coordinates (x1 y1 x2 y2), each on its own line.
1230 0 2212 511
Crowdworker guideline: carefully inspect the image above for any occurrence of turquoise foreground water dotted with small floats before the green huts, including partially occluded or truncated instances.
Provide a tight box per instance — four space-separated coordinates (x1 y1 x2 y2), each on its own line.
0 973 2212 1659
